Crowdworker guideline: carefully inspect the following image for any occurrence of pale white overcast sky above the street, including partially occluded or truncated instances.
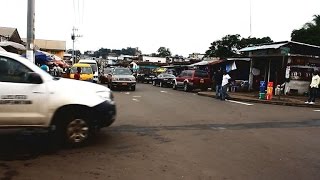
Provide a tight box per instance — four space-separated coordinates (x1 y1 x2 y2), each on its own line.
0 0 320 56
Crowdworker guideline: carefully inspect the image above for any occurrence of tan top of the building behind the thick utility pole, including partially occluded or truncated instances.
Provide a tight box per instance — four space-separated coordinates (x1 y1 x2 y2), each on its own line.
22 38 66 51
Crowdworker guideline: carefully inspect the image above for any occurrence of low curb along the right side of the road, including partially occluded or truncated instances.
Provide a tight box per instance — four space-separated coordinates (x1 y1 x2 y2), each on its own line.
198 92 320 108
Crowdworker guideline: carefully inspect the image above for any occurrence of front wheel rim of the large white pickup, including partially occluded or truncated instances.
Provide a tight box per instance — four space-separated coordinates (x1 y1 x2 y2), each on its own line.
67 119 89 143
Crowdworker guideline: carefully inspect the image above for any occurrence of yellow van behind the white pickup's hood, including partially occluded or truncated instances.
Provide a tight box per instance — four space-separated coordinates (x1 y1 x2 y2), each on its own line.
70 64 93 82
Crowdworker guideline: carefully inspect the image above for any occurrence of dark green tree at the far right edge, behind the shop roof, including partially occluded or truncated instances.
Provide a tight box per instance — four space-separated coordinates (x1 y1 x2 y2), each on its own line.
291 15 320 46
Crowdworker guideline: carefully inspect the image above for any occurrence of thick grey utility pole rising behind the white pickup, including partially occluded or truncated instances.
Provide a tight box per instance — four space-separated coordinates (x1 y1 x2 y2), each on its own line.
26 0 35 63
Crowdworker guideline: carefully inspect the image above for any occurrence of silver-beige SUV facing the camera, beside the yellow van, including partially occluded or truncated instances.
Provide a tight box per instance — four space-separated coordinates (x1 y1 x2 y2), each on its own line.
109 68 136 91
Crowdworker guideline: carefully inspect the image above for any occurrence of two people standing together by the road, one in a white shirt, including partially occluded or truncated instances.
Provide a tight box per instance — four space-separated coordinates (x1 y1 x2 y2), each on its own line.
213 69 231 101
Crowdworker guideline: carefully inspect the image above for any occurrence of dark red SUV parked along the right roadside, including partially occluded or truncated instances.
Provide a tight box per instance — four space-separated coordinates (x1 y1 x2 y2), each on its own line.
172 70 211 91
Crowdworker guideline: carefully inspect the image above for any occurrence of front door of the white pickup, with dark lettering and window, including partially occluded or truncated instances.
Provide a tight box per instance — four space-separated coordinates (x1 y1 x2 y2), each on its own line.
0 56 48 126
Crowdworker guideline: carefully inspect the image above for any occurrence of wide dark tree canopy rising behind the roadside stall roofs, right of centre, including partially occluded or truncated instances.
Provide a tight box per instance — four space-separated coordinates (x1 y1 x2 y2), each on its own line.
206 34 273 58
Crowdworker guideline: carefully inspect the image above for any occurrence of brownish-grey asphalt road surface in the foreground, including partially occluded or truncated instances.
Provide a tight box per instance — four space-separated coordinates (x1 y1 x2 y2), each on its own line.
0 84 320 180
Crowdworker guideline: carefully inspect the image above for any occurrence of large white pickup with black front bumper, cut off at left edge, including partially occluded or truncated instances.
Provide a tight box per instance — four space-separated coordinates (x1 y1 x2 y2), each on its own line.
0 51 116 145
